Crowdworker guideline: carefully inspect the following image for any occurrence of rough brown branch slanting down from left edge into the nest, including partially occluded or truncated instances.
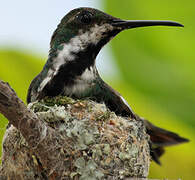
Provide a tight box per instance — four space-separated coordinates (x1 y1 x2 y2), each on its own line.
0 80 65 176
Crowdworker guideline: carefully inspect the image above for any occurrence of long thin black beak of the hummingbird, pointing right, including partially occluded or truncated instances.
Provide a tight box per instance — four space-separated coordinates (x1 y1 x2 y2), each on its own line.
112 19 184 29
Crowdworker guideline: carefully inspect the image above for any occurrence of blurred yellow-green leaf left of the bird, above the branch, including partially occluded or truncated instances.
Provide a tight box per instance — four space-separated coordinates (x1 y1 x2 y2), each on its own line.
0 49 44 102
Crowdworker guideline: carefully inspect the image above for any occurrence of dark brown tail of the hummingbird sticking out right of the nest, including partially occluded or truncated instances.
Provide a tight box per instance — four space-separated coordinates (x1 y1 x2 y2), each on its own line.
143 119 189 165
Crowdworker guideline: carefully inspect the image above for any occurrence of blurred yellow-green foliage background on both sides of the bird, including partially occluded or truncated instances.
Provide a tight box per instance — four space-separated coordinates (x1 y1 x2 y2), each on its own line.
0 0 195 180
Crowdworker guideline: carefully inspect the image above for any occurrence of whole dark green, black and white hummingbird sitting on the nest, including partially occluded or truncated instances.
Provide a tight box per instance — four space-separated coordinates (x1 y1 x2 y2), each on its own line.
27 7 188 164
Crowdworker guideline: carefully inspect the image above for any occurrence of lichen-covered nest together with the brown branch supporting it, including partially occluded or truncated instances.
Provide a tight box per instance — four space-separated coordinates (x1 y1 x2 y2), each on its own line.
0 81 150 180
